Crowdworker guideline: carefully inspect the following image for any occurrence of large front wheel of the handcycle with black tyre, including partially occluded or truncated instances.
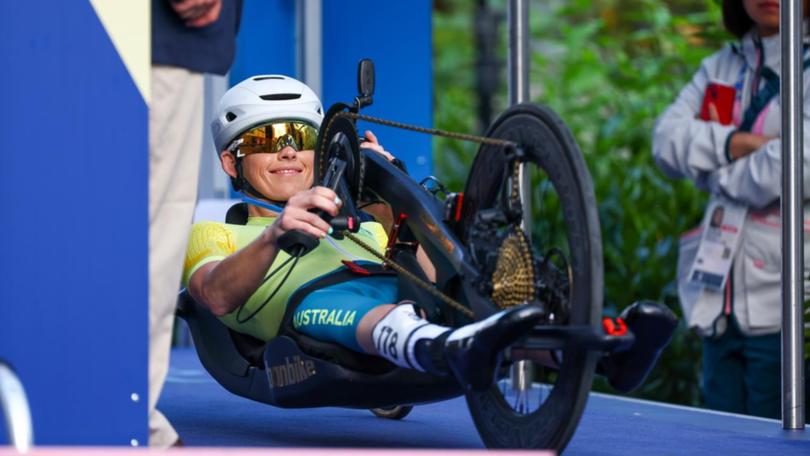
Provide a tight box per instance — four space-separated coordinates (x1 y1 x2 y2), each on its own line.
458 104 603 451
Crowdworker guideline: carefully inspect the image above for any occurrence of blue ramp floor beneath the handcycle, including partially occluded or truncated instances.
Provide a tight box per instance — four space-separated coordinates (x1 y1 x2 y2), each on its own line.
158 349 810 456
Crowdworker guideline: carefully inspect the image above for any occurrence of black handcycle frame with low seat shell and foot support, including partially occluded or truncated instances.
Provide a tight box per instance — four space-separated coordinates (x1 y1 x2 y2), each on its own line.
178 67 634 446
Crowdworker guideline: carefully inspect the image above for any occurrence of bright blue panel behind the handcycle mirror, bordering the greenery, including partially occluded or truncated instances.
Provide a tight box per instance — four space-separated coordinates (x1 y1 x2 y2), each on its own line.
323 0 433 179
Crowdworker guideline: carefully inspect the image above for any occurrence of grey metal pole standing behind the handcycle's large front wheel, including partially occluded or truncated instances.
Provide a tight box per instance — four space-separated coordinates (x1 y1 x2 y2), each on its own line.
508 0 532 400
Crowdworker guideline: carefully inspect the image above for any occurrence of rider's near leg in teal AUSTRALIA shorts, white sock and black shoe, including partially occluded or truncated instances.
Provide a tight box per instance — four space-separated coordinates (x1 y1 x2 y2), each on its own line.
293 277 541 389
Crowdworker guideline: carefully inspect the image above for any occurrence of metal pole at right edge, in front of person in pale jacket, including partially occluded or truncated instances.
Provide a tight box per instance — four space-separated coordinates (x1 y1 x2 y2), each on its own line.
780 0 804 429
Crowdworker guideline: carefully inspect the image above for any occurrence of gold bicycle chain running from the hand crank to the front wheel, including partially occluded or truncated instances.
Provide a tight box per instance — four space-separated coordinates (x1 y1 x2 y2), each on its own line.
326 111 522 319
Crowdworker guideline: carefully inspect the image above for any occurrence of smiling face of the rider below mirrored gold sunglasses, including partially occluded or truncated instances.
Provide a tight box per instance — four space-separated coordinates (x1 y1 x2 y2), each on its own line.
222 146 315 201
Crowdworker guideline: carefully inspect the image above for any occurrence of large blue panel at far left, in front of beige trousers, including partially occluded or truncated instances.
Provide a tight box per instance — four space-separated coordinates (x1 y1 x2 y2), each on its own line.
0 0 148 445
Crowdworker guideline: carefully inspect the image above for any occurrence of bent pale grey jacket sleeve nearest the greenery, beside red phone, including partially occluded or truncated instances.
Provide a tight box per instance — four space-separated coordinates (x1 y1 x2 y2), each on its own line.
653 57 735 190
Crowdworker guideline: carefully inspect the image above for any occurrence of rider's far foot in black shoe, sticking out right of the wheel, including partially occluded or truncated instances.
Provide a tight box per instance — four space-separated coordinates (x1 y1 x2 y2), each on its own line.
597 301 678 393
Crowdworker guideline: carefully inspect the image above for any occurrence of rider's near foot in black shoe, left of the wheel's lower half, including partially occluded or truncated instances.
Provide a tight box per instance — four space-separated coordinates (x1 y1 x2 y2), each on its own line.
444 305 542 391
